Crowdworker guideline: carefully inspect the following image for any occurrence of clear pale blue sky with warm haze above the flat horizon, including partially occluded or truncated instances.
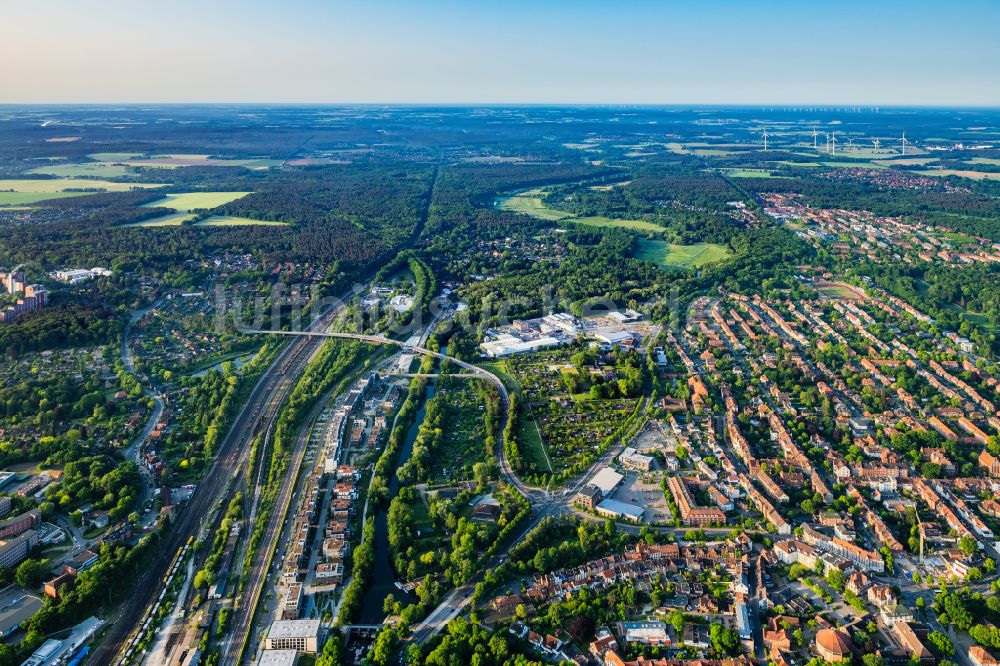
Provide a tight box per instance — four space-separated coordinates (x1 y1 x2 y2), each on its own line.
0 0 1000 106
